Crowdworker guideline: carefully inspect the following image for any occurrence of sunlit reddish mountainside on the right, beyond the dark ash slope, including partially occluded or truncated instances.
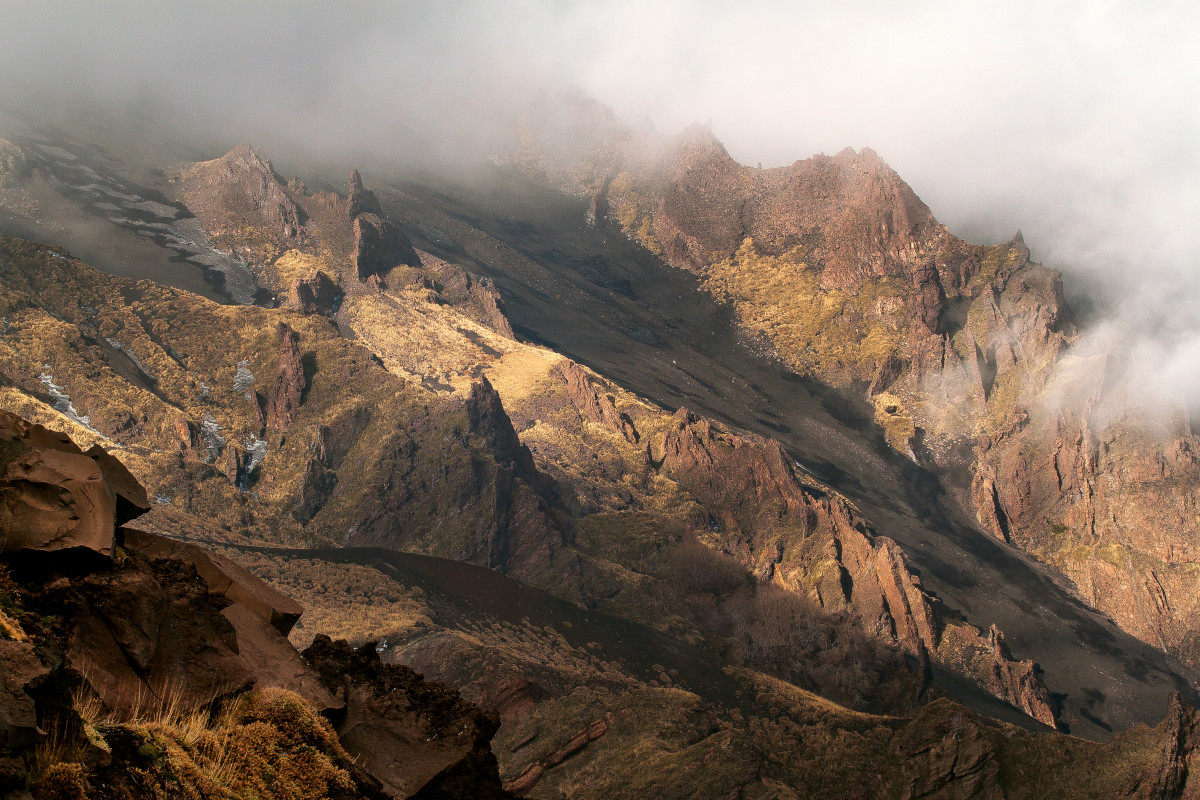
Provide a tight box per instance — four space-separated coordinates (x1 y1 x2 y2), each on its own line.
501 110 1200 681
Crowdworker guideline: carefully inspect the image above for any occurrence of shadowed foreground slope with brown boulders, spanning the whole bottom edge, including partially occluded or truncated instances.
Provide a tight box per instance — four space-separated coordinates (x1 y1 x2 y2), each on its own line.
0 414 1196 799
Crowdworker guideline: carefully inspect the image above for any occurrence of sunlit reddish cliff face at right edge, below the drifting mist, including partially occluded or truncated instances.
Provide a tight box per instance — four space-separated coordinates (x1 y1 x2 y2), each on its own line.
972 388 1200 667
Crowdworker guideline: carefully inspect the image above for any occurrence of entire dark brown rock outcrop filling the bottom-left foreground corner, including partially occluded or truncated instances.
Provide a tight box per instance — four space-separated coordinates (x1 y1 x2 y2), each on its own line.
0 414 511 799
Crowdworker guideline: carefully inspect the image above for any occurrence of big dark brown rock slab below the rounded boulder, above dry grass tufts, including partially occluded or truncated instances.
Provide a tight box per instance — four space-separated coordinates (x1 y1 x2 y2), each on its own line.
62 530 341 712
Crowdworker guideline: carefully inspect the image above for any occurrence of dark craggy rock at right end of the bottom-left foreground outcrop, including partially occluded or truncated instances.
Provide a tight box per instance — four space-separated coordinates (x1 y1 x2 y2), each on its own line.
304 636 510 798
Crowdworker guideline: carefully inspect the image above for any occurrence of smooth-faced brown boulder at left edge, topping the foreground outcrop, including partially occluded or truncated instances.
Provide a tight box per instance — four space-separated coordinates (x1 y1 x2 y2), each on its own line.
0 411 150 555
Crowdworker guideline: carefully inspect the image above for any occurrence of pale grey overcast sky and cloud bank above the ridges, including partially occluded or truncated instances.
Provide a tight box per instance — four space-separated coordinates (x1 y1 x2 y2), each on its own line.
7 0 1200 407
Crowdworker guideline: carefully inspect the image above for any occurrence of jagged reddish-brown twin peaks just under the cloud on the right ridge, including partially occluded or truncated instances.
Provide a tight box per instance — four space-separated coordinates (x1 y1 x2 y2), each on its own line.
606 126 946 288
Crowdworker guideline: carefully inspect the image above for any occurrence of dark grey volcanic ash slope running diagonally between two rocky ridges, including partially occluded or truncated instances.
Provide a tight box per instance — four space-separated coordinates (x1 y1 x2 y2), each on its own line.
388 175 1195 739
